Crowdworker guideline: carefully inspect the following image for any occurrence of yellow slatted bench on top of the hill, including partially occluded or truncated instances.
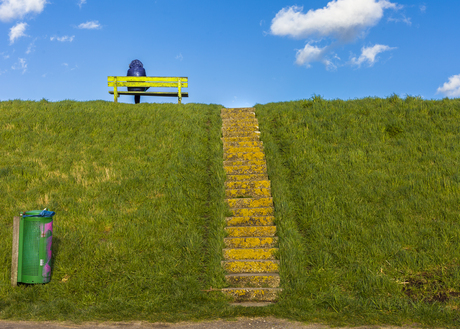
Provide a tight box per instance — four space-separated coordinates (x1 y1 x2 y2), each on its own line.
107 76 188 104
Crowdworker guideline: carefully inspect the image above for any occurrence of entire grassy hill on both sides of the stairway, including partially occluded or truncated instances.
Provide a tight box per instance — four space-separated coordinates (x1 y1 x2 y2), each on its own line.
0 96 460 327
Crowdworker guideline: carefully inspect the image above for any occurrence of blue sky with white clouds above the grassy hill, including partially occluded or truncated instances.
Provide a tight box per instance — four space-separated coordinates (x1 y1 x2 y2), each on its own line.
0 0 460 107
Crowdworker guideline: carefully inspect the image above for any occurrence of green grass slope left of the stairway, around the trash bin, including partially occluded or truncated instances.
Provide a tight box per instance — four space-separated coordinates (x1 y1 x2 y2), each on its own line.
0 101 230 321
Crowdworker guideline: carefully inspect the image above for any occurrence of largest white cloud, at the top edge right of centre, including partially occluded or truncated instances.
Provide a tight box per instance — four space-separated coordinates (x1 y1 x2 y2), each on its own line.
271 0 399 42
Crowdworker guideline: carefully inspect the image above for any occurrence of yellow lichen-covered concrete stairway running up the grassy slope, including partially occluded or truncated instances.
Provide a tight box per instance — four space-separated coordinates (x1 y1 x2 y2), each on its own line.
221 108 280 302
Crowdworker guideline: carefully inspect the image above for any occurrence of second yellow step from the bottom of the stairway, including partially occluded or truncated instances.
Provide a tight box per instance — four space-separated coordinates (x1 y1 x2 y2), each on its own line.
225 273 280 288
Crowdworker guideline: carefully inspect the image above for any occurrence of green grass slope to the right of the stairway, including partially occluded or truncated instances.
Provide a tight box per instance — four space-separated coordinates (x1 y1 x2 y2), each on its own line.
256 96 460 327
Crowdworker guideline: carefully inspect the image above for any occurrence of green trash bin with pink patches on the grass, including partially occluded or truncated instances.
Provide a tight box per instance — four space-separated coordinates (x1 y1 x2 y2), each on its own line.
17 209 55 284
